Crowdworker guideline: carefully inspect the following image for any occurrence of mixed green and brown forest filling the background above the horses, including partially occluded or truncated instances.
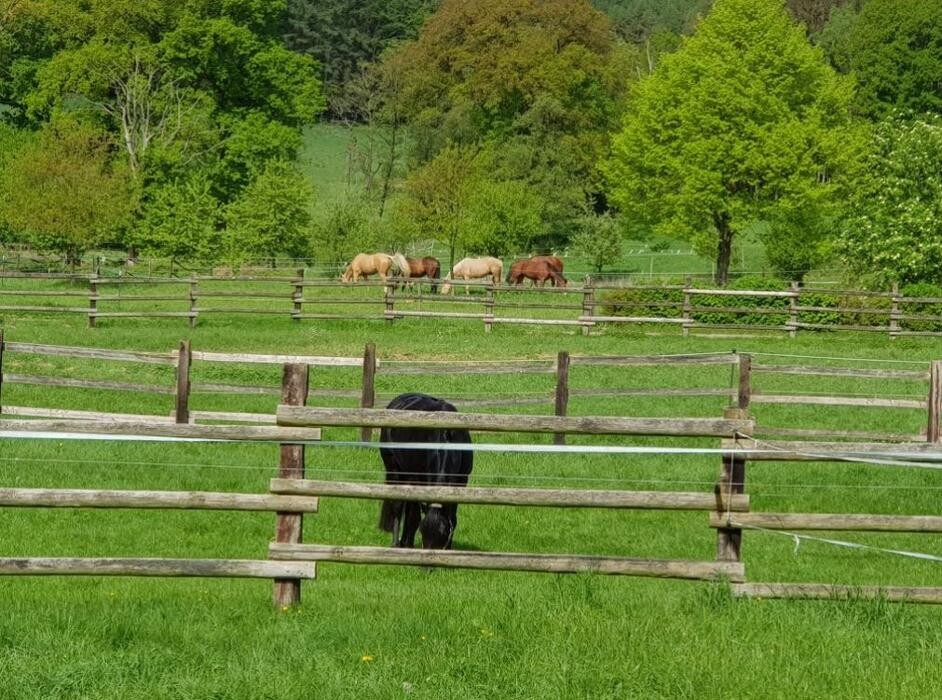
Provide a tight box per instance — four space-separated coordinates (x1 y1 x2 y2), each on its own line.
0 0 942 285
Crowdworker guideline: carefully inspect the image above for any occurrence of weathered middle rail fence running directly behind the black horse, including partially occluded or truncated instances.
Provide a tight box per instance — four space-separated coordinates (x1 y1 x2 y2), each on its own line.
0 332 942 444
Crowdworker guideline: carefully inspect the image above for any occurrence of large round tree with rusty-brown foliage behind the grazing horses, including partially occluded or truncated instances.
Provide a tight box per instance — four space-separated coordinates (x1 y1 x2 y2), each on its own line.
394 0 625 246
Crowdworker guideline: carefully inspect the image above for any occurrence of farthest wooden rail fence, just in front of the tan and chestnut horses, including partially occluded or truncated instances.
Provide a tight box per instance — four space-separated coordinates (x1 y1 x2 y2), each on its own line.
0 271 942 338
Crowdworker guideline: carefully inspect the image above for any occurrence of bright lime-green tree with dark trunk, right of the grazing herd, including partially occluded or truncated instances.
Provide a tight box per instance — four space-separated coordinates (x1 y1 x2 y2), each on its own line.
606 0 858 285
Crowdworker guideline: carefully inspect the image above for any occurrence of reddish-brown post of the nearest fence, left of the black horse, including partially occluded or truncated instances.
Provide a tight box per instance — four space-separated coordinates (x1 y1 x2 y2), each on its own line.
272 363 308 608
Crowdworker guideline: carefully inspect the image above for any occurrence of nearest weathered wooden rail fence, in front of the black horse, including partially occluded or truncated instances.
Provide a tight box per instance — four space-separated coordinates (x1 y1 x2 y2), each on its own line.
0 361 942 606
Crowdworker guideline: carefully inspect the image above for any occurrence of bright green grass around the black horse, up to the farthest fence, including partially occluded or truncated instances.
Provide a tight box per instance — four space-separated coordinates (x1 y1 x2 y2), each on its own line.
0 315 942 698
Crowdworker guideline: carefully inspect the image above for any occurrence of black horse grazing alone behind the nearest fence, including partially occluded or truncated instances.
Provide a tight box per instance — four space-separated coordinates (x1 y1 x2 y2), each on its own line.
379 394 474 549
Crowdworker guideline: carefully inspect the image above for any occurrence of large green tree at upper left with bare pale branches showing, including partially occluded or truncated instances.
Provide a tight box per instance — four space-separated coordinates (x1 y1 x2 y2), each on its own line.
0 0 324 258
